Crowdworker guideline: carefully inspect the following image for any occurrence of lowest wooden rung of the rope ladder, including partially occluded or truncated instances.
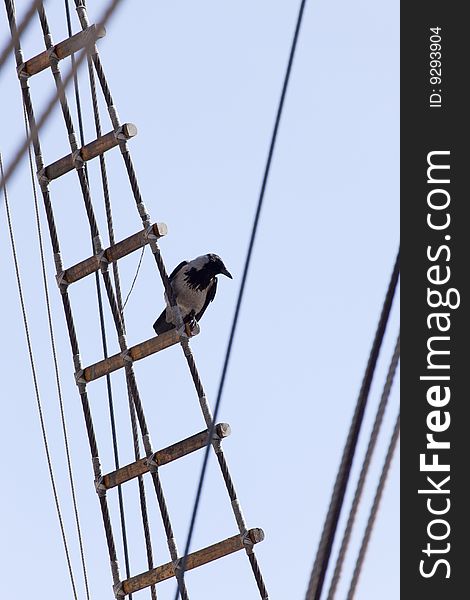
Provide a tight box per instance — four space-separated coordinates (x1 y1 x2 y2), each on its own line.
121 528 264 596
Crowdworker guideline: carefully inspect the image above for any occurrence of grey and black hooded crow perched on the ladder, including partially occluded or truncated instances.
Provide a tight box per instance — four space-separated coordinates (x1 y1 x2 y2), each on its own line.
153 254 233 335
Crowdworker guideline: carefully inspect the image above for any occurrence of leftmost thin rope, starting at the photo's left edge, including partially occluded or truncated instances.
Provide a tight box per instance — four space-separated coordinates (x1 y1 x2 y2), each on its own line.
0 153 78 600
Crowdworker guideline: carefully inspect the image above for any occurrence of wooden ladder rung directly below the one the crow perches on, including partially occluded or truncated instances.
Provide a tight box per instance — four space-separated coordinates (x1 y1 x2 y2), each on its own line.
103 423 230 490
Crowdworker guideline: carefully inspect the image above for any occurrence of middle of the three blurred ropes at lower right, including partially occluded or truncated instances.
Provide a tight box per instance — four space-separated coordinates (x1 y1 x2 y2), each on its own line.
327 335 400 600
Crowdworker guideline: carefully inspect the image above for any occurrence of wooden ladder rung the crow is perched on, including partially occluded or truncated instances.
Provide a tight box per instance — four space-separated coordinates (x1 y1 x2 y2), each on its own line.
82 329 194 383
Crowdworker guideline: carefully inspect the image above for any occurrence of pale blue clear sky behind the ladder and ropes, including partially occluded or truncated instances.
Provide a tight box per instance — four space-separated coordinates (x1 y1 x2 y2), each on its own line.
0 0 399 600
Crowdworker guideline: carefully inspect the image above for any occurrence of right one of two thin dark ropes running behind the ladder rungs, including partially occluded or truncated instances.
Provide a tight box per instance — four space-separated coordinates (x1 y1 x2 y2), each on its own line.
76 0 157 600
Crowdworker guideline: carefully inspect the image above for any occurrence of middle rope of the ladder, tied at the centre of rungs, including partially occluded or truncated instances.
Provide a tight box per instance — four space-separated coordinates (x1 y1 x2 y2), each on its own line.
39 5 189 600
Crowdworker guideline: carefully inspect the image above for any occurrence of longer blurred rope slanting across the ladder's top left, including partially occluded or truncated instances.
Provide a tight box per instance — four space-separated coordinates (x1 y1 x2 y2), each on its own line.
0 0 122 196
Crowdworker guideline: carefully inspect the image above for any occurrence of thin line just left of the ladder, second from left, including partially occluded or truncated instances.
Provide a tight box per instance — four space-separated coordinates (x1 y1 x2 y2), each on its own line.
23 104 90 600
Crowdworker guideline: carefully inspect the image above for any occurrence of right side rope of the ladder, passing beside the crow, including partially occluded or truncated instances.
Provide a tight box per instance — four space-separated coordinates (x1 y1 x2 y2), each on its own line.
75 0 268 599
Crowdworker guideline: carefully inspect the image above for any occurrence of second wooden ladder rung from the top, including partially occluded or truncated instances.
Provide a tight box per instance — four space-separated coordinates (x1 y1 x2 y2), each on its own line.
43 123 137 182
